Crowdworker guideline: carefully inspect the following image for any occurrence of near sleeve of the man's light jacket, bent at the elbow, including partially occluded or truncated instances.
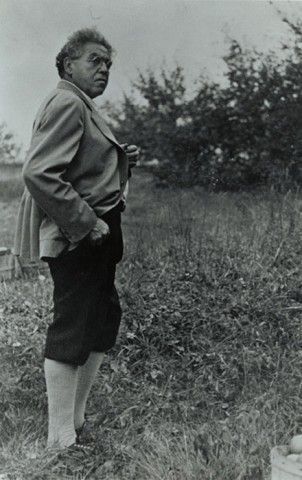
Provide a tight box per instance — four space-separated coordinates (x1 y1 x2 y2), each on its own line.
23 94 97 242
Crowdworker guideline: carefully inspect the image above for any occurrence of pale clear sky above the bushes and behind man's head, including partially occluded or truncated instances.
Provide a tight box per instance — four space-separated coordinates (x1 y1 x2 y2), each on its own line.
0 0 302 149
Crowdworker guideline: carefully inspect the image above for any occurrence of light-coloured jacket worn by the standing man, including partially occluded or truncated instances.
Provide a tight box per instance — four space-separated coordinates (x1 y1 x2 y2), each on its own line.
13 80 129 260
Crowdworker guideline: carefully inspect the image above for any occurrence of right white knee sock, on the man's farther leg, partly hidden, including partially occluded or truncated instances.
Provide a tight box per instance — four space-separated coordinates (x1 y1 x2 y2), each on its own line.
74 352 105 428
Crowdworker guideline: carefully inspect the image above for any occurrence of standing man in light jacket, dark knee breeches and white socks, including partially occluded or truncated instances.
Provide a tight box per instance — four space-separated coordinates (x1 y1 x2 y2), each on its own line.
14 29 138 449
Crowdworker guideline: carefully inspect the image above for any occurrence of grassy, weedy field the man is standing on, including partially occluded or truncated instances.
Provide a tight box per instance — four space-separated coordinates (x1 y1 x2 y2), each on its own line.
0 172 302 480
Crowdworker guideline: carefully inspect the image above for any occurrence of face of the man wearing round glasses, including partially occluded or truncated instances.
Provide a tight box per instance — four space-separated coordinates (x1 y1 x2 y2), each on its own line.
66 43 111 98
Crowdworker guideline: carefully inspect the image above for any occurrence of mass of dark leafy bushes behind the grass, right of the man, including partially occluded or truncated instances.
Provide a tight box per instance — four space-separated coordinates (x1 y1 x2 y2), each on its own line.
105 19 302 189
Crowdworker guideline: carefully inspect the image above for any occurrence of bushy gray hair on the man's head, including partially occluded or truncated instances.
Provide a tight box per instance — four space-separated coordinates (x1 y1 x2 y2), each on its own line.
56 28 114 78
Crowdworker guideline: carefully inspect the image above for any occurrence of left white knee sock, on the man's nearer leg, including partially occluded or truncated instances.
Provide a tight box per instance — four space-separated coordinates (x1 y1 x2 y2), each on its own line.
44 358 78 448
